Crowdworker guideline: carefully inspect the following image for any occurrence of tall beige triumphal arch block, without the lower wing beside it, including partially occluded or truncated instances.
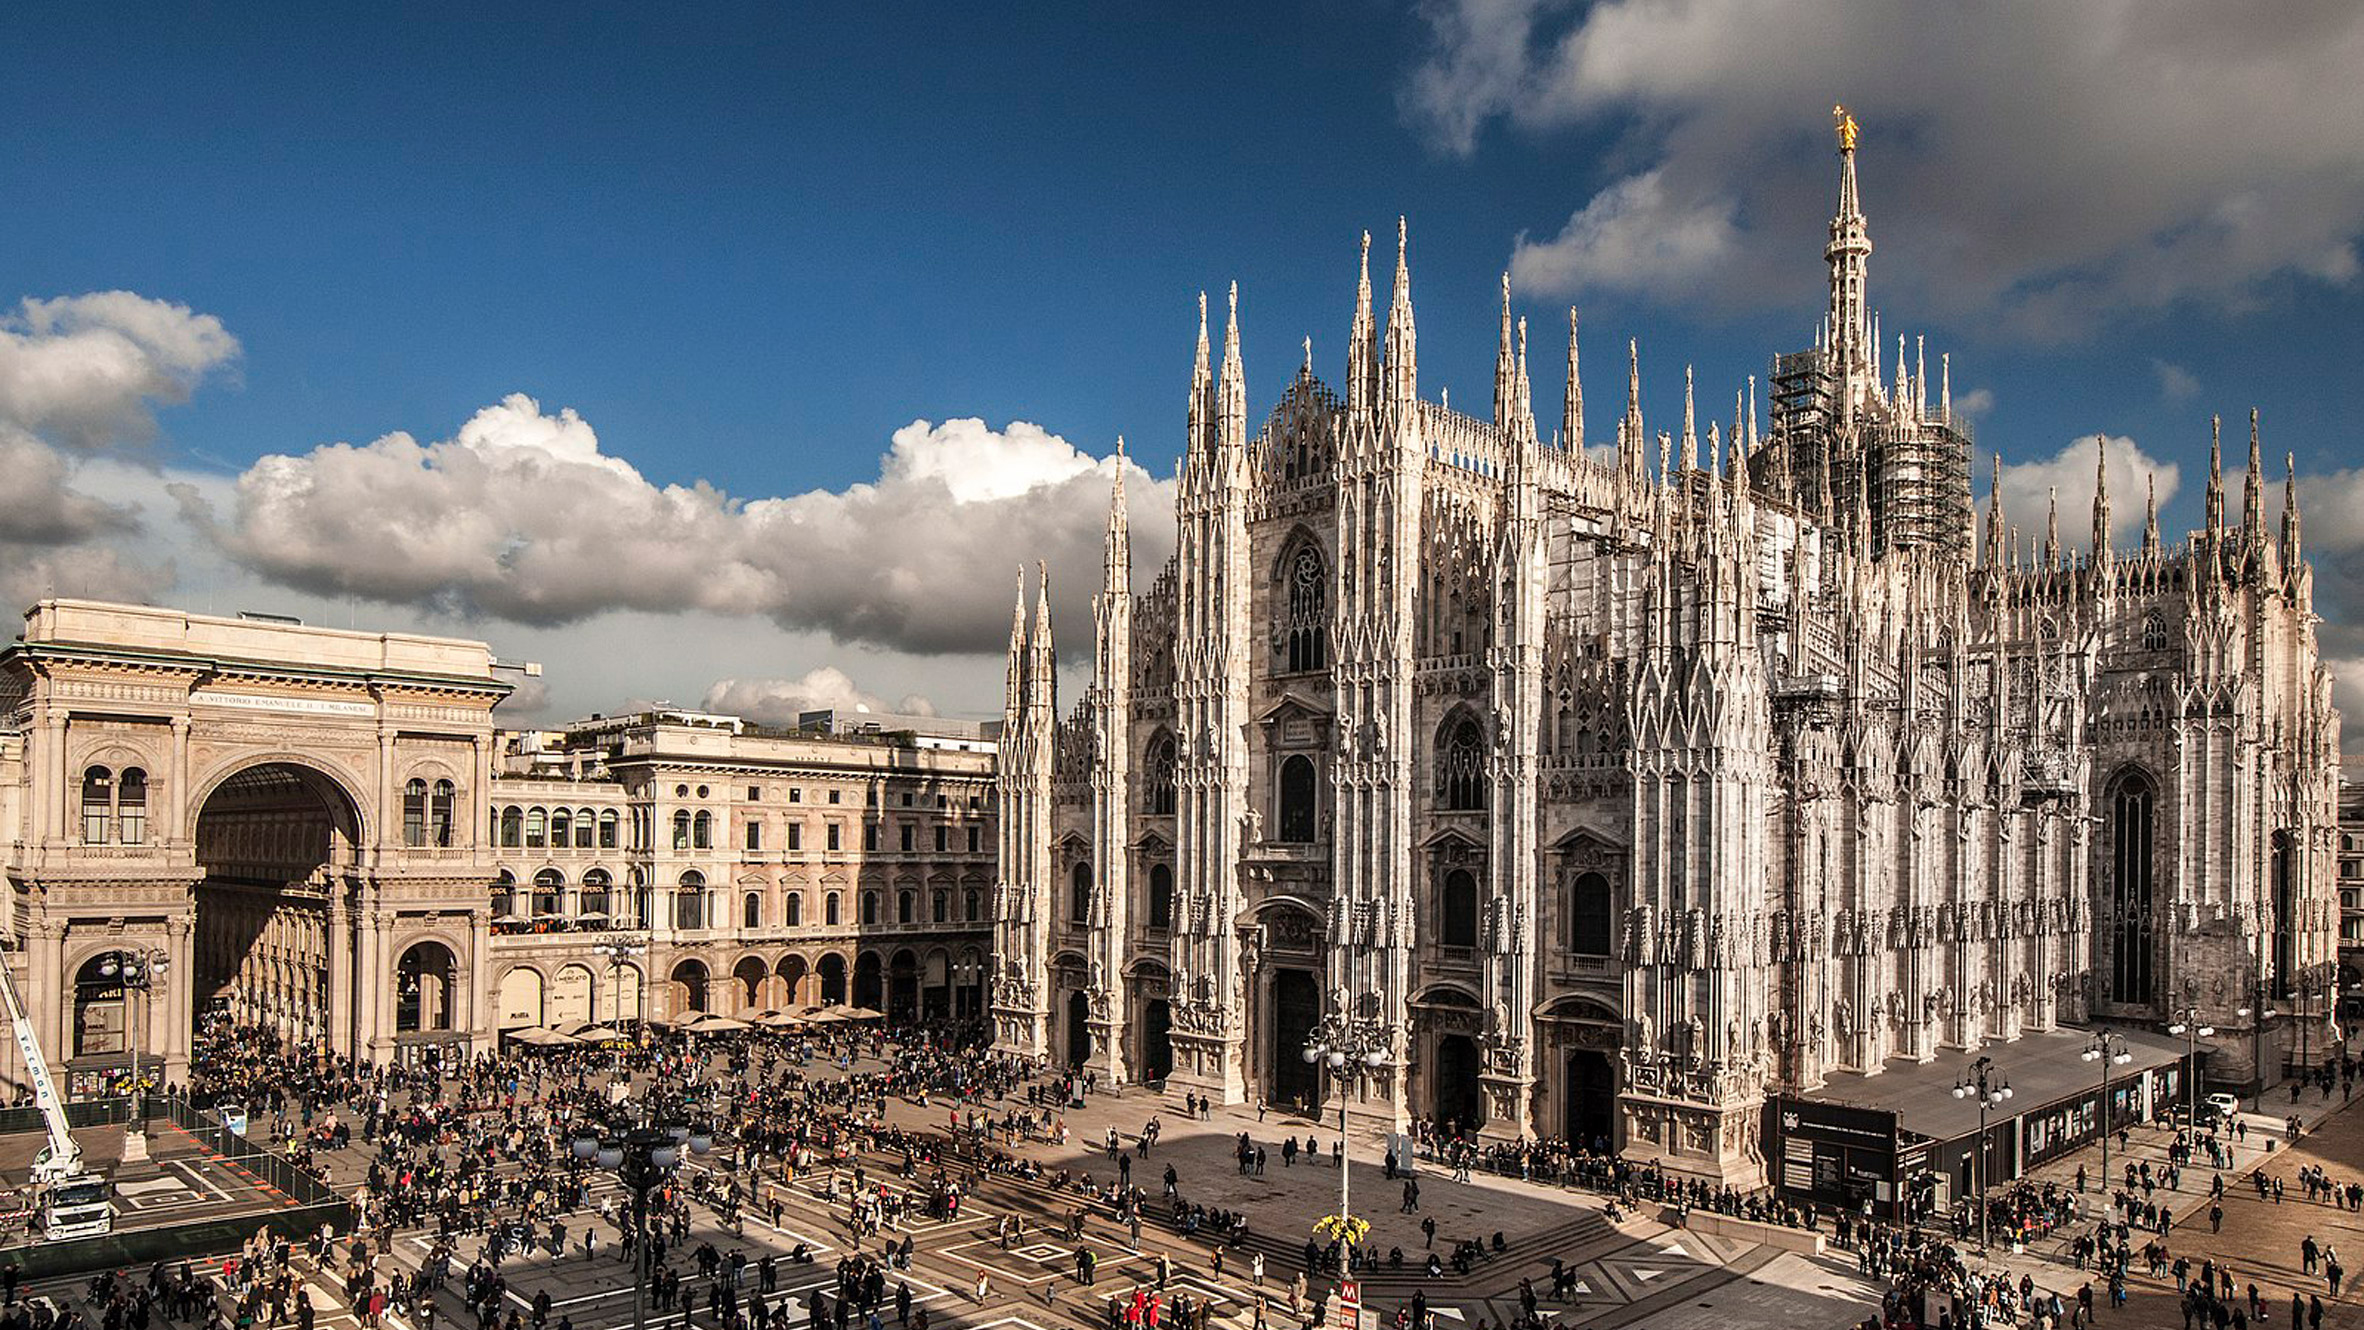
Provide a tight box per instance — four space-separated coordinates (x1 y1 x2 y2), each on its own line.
0 600 511 1096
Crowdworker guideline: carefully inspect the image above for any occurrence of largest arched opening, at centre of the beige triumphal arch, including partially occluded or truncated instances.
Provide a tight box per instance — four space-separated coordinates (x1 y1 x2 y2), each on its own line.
191 761 356 1049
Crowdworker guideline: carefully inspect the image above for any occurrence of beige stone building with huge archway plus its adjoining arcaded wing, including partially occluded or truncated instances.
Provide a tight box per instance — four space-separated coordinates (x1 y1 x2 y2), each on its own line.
0 600 995 1098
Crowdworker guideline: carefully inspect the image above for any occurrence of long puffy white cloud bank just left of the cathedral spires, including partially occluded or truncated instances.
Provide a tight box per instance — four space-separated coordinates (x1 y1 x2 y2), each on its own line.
182 395 1173 654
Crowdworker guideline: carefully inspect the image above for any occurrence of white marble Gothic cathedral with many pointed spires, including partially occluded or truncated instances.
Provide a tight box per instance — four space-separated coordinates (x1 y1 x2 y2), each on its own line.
988 123 2338 1186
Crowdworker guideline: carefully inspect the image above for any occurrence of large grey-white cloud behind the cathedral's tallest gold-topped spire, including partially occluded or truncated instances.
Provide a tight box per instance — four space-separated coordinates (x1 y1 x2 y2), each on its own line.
1402 0 2364 335
